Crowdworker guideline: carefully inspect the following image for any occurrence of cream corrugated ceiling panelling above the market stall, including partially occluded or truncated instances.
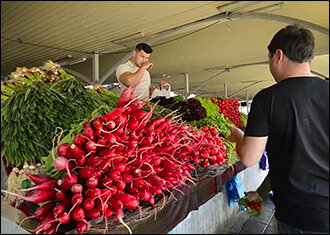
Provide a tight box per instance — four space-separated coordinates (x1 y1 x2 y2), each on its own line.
1 1 329 97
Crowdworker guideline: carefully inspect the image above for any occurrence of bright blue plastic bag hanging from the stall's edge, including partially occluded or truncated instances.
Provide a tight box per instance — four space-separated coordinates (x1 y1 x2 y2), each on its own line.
225 175 245 206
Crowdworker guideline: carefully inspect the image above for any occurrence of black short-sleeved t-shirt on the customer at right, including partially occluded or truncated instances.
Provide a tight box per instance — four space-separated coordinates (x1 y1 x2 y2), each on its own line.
244 77 329 232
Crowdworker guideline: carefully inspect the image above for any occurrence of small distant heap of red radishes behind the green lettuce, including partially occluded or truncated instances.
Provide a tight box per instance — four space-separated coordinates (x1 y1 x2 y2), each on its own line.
211 97 242 127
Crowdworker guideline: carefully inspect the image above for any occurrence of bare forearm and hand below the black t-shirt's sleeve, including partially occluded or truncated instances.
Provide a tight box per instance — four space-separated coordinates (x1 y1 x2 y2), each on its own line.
227 126 268 167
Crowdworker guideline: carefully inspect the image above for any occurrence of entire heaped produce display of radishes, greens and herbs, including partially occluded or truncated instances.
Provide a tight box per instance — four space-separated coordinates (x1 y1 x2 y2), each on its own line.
1 61 248 234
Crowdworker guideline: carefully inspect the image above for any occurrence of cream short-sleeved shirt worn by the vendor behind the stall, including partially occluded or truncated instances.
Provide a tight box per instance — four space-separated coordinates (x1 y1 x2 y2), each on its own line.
116 60 151 100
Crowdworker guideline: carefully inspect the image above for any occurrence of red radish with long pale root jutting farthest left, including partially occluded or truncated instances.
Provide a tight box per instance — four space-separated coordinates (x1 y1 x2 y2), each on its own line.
1 189 56 203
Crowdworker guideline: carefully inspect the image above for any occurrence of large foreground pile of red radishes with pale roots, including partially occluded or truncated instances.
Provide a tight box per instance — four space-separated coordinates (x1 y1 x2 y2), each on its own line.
3 87 226 234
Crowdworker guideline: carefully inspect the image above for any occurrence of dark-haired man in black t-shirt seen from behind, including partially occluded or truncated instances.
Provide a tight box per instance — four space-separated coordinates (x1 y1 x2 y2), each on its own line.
228 25 329 234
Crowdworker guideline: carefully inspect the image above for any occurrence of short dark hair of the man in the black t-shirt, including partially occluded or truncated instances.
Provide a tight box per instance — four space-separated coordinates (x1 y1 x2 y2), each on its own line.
267 24 314 63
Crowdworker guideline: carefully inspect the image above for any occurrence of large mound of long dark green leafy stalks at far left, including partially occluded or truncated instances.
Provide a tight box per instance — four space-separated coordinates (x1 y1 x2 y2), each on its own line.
1 76 109 166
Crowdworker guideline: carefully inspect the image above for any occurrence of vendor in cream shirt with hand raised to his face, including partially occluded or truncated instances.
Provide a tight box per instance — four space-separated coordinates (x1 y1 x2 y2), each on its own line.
116 43 168 100
